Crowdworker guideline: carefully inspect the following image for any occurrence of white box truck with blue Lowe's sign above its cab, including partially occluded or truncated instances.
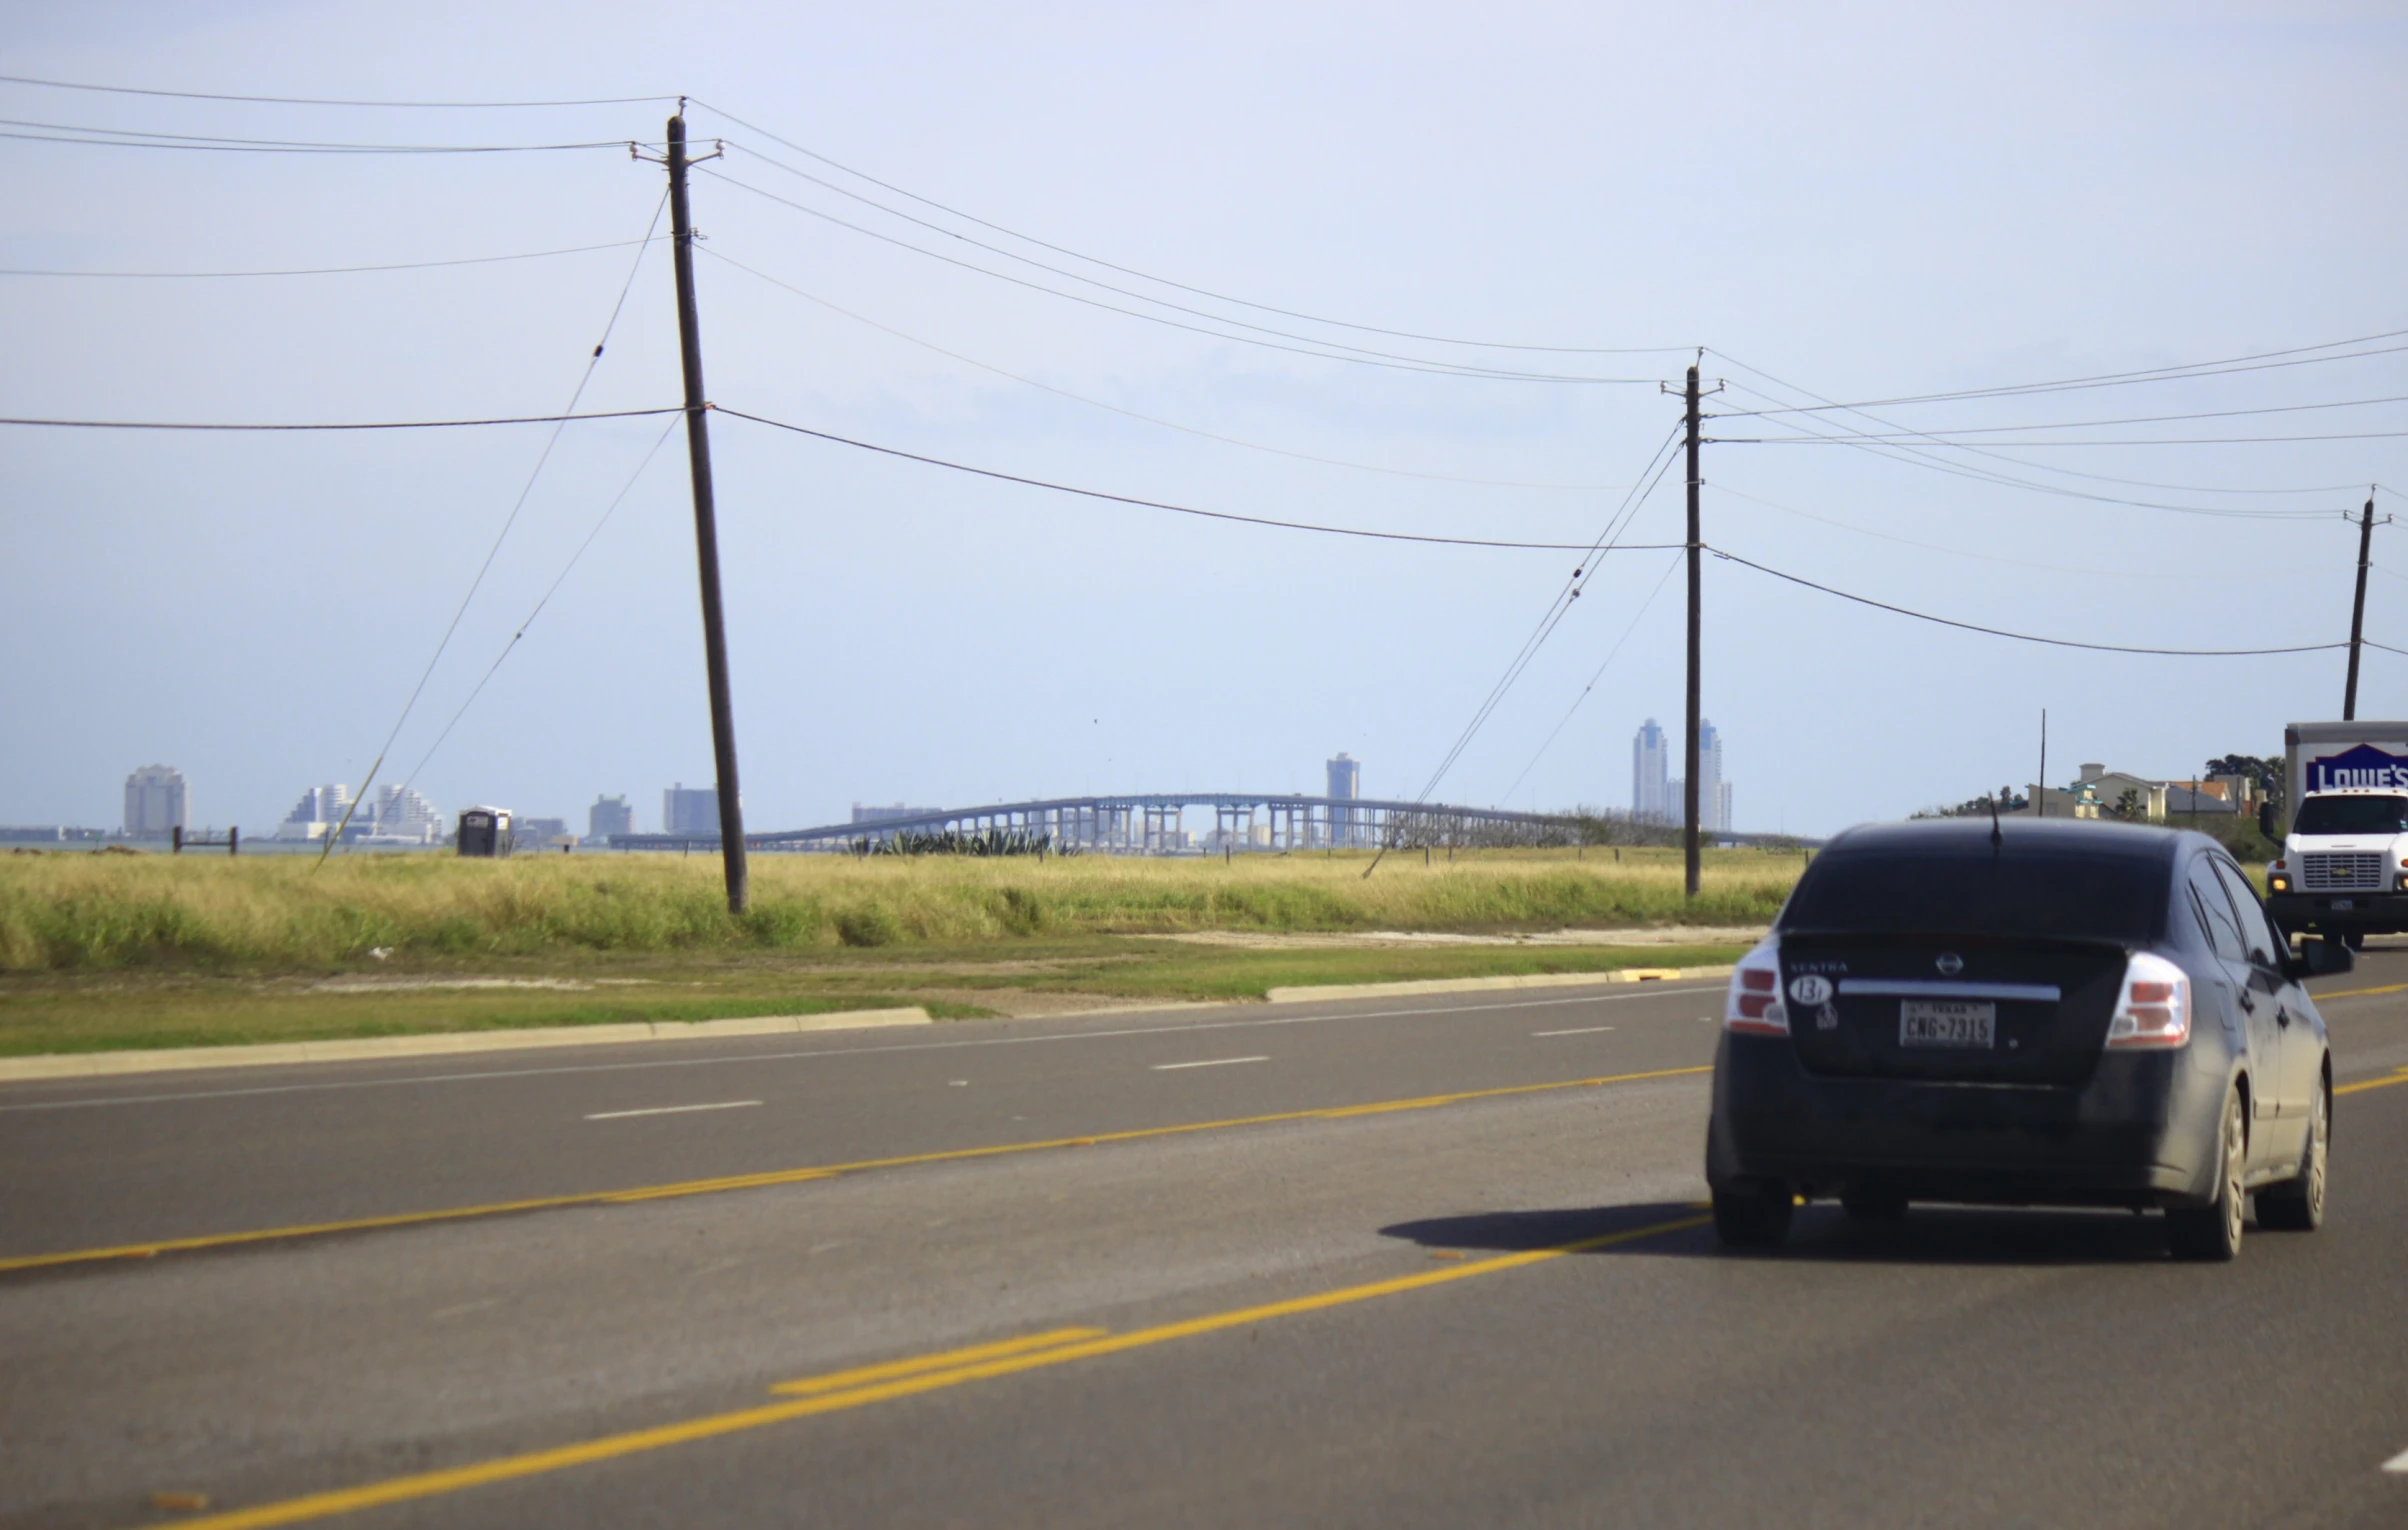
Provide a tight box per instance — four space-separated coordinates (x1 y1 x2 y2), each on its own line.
2266 723 2408 947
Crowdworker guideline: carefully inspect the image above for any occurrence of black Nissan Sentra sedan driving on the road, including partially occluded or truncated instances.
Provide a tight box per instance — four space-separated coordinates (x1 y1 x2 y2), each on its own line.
1705 819 2350 1260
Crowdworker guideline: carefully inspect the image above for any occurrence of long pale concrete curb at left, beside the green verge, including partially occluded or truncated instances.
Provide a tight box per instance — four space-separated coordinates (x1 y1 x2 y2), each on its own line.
0 1005 934 1082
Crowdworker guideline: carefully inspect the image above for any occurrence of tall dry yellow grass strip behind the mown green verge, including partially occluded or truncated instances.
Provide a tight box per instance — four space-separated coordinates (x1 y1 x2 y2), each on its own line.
0 848 1801 973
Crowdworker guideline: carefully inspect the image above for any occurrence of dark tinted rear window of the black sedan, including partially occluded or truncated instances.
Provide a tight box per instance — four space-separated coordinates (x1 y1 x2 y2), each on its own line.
1780 848 2167 942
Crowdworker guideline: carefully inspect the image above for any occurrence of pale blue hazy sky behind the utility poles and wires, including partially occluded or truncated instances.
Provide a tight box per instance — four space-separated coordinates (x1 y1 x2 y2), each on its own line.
0 5 2408 834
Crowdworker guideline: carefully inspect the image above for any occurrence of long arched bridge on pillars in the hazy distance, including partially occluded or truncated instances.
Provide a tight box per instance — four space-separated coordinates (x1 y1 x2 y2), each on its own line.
609 793 1794 855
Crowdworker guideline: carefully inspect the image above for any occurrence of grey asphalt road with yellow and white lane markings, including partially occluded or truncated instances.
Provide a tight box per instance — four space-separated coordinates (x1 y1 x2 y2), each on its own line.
0 952 2408 1528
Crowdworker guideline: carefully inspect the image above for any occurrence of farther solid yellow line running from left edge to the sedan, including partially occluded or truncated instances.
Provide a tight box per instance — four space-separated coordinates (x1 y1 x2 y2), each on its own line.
0 1063 1714 1275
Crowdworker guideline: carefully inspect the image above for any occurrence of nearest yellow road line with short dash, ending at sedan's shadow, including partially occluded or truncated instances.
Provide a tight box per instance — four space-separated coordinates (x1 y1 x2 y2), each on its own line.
178 1217 1712 1530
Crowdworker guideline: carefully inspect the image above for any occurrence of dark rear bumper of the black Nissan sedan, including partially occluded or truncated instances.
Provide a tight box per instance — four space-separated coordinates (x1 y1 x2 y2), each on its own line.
1705 1034 2225 1205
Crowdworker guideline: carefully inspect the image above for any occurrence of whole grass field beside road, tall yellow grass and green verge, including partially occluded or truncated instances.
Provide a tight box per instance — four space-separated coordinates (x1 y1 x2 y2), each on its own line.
0 848 1801 1055
